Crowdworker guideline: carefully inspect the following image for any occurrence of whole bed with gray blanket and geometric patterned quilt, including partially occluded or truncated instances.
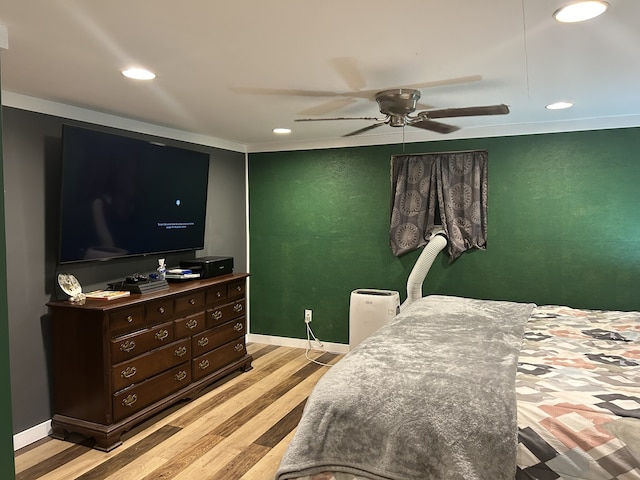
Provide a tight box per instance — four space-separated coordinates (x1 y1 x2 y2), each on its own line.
276 295 640 480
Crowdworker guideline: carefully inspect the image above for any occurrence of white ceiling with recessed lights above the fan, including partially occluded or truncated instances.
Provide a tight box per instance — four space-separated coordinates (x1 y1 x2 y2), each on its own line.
0 0 640 151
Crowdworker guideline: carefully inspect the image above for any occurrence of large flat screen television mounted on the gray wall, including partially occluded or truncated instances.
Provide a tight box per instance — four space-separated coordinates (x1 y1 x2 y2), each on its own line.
59 125 209 264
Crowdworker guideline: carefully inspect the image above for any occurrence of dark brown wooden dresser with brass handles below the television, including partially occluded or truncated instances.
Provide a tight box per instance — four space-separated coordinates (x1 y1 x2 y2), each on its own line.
47 273 253 451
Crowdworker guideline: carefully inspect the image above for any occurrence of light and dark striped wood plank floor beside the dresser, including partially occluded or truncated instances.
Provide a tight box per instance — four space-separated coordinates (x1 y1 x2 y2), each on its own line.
15 344 342 480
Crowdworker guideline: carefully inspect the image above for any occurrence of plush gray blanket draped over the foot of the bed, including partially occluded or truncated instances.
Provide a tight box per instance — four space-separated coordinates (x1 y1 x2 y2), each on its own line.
276 296 534 480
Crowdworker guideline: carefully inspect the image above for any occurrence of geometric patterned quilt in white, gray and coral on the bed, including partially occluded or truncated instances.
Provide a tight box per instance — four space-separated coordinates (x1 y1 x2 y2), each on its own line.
284 306 640 480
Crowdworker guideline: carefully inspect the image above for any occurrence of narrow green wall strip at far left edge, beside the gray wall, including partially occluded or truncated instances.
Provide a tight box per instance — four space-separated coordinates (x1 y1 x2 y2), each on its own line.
0 65 15 479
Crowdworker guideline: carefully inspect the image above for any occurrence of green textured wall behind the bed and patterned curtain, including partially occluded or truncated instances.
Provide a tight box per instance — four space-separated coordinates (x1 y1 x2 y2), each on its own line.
249 128 640 344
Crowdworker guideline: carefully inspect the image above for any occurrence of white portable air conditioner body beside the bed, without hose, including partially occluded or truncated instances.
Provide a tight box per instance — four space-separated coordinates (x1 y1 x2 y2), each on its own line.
349 289 400 350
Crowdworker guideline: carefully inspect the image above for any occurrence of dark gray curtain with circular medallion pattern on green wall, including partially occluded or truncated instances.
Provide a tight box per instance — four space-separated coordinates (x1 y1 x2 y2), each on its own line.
389 150 488 263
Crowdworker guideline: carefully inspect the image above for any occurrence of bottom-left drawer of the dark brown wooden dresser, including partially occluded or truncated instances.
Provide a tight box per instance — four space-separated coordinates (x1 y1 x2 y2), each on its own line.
113 363 191 421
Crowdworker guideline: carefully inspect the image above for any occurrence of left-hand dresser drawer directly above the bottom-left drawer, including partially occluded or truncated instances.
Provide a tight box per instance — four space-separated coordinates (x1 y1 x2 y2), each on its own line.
111 338 191 392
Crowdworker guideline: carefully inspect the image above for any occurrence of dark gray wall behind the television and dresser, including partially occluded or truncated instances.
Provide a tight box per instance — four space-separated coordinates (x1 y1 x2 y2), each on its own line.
2 107 247 433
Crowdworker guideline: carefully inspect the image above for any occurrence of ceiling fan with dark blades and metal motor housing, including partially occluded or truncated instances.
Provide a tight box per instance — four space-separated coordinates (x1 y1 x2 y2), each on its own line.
295 88 509 137
